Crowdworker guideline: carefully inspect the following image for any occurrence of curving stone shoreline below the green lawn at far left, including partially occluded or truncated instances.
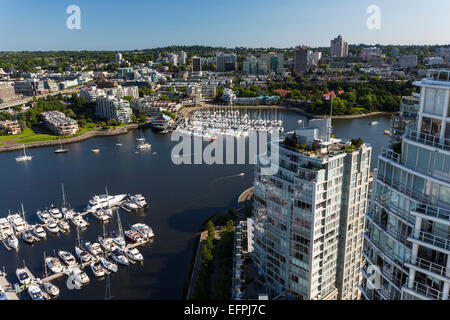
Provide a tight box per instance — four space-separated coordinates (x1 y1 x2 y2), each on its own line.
0 123 150 152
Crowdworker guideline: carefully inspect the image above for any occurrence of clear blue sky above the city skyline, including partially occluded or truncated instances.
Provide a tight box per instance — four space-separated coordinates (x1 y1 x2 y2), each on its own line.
0 0 450 51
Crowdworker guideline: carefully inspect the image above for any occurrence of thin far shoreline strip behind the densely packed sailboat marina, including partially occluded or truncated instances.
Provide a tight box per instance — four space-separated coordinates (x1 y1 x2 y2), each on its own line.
181 104 398 120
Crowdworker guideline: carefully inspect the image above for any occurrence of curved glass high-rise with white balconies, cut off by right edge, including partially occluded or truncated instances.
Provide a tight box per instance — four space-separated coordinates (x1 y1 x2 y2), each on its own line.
361 70 450 300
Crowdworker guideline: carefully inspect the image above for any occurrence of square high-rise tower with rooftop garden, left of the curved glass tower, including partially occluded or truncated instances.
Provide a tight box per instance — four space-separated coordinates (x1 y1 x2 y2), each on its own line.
252 118 372 300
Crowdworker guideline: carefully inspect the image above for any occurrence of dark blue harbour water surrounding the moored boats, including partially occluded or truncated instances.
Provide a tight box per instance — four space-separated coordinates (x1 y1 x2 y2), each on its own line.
0 113 390 299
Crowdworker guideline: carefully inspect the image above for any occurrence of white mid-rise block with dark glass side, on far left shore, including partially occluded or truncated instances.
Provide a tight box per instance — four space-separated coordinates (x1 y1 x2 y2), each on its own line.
95 96 133 123
